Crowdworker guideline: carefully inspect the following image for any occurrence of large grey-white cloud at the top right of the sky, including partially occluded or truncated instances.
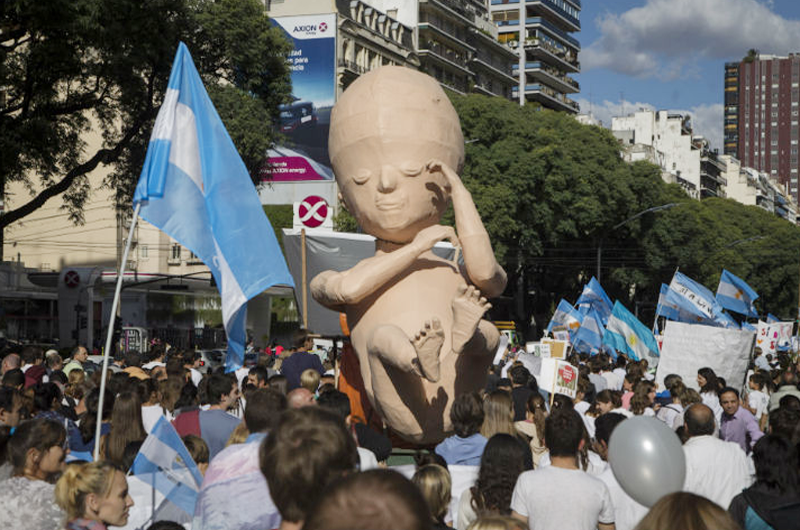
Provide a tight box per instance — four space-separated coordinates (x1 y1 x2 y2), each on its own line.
581 0 800 79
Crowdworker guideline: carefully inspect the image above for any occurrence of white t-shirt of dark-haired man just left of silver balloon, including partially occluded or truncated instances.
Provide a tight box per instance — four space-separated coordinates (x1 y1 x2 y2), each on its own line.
511 466 614 530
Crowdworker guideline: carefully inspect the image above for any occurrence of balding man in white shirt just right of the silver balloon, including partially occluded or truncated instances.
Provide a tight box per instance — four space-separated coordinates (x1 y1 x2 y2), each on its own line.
683 403 752 509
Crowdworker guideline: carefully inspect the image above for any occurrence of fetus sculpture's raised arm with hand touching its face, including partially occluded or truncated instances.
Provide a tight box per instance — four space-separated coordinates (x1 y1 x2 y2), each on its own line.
427 159 507 298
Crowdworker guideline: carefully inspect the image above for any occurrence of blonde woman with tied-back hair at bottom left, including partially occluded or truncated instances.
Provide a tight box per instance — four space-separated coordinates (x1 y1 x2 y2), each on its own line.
55 462 133 530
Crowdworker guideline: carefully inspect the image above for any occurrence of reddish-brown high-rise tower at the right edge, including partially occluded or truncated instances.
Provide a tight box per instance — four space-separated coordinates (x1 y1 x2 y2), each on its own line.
725 53 800 200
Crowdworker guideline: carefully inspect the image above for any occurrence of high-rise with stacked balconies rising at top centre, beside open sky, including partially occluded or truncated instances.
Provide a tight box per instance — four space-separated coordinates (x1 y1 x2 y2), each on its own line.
490 0 581 113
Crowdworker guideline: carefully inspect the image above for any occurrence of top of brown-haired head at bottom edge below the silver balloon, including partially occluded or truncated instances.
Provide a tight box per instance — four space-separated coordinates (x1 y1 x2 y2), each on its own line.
634 491 741 530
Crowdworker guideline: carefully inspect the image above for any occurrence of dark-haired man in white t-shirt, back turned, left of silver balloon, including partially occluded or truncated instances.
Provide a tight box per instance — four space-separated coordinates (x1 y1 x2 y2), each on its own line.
511 410 615 530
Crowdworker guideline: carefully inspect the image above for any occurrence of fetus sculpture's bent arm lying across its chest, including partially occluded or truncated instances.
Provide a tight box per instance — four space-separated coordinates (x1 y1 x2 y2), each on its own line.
311 225 459 310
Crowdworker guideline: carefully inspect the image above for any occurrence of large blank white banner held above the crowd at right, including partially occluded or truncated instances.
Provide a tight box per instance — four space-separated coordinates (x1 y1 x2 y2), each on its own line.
656 321 755 390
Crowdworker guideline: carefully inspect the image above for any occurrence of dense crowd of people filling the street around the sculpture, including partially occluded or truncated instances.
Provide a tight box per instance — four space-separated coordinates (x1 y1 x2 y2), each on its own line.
0 331 800 530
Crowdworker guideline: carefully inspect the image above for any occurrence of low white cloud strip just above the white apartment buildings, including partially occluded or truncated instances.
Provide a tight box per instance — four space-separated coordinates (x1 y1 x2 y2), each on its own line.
576 98 724 152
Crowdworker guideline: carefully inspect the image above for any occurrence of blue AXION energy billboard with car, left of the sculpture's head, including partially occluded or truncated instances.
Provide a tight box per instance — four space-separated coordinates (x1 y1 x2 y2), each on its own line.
262 13 336 182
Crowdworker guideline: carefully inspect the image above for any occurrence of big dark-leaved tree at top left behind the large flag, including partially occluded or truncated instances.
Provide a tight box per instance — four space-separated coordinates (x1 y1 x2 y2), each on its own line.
0 0 291 252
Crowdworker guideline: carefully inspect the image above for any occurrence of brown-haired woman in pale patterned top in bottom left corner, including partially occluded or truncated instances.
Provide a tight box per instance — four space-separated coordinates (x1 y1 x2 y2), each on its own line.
0 418 69 530
